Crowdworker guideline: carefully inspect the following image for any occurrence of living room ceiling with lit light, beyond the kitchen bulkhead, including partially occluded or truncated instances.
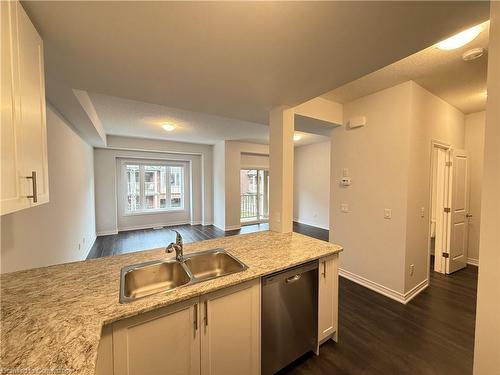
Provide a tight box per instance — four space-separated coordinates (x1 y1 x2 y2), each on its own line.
89 93 329 146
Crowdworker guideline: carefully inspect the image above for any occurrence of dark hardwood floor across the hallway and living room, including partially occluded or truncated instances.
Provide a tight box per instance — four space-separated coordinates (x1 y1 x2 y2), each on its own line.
89 223 477 375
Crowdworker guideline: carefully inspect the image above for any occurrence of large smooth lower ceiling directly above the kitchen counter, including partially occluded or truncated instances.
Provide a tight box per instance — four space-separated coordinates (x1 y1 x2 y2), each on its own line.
23 1 489 126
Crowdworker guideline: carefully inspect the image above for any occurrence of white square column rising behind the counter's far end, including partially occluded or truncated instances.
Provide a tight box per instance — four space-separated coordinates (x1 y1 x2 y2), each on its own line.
269 107 294 233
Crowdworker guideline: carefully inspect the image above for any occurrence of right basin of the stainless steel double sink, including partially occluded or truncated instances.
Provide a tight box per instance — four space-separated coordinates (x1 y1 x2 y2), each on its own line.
184 249 248 281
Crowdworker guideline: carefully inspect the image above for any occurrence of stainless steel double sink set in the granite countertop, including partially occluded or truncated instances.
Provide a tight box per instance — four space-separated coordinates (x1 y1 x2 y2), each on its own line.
120 249 248 303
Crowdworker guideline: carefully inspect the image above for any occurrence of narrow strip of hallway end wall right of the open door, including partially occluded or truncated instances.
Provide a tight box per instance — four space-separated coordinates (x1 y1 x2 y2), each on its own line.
465 111 486 262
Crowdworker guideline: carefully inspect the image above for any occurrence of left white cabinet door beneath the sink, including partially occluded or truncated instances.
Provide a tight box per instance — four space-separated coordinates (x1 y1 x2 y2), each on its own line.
113 298 201 375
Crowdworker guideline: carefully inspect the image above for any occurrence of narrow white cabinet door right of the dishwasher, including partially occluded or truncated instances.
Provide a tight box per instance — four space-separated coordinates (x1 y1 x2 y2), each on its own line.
318 254 338 343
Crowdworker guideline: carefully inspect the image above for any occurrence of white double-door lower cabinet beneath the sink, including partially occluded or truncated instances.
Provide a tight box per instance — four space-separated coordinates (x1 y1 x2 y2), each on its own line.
96 280 260 375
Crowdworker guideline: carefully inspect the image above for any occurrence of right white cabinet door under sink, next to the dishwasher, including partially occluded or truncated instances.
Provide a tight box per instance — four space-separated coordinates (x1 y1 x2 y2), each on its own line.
200 280 260 375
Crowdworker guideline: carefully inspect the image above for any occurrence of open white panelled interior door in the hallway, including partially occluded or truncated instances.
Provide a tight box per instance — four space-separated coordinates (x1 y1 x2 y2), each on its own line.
446 150 469 273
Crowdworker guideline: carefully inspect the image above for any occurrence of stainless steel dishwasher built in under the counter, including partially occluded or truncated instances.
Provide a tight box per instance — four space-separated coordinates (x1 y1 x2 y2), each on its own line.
261 261 318 375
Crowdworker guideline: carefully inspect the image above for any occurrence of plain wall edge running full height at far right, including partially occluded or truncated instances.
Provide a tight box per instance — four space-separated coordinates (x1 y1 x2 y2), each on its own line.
474 1 500 375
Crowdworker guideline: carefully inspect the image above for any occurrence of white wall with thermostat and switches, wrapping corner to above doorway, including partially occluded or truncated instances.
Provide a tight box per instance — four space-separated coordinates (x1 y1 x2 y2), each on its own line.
330 81 465 300
